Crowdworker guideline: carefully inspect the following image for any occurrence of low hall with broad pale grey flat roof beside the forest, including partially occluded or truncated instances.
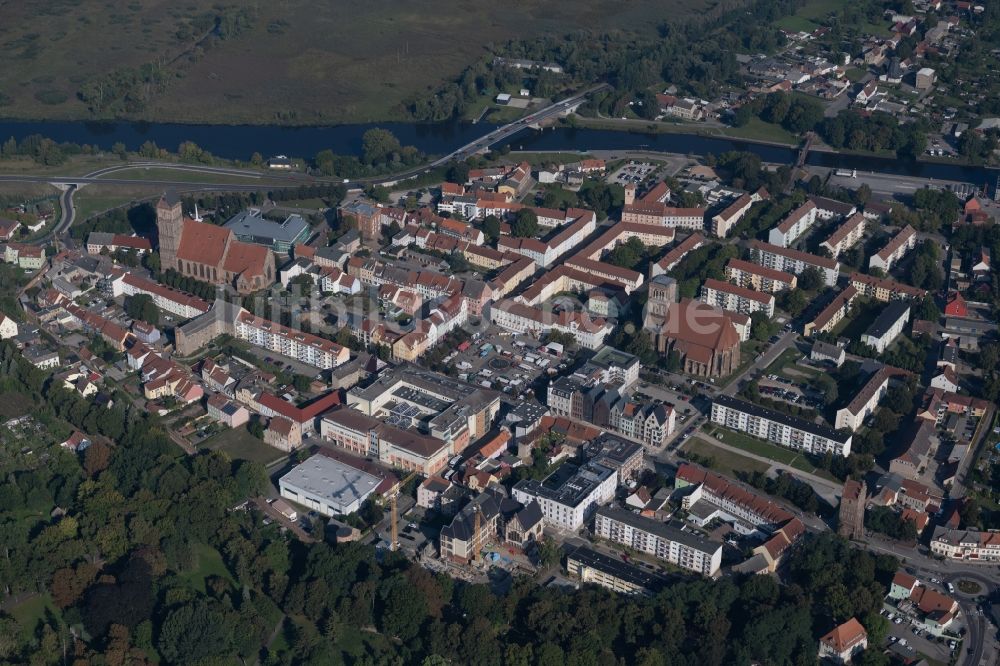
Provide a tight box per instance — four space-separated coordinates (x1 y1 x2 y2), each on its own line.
278 454 383 518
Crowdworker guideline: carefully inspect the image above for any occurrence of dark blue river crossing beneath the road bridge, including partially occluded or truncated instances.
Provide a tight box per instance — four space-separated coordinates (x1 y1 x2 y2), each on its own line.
0 121 1000 189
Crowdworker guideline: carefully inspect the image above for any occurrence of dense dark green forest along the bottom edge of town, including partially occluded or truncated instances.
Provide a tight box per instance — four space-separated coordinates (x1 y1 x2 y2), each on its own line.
0 343 898 665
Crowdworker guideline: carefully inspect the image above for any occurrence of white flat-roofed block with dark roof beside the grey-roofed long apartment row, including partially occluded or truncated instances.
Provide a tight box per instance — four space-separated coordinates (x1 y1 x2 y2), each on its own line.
513 462 618 532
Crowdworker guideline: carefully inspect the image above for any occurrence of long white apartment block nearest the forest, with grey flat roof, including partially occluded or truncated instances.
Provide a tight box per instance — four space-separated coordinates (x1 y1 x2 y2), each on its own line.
594 507 722 576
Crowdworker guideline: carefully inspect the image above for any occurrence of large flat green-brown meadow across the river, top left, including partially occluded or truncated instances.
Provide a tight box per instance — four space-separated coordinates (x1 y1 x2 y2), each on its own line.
0 0 714 124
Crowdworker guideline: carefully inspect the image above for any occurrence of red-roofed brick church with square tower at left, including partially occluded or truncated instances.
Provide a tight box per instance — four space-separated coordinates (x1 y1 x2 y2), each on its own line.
156 192 275 294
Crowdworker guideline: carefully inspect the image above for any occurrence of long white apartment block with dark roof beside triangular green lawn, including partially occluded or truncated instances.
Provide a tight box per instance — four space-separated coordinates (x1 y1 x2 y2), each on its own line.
712 395 851 456
